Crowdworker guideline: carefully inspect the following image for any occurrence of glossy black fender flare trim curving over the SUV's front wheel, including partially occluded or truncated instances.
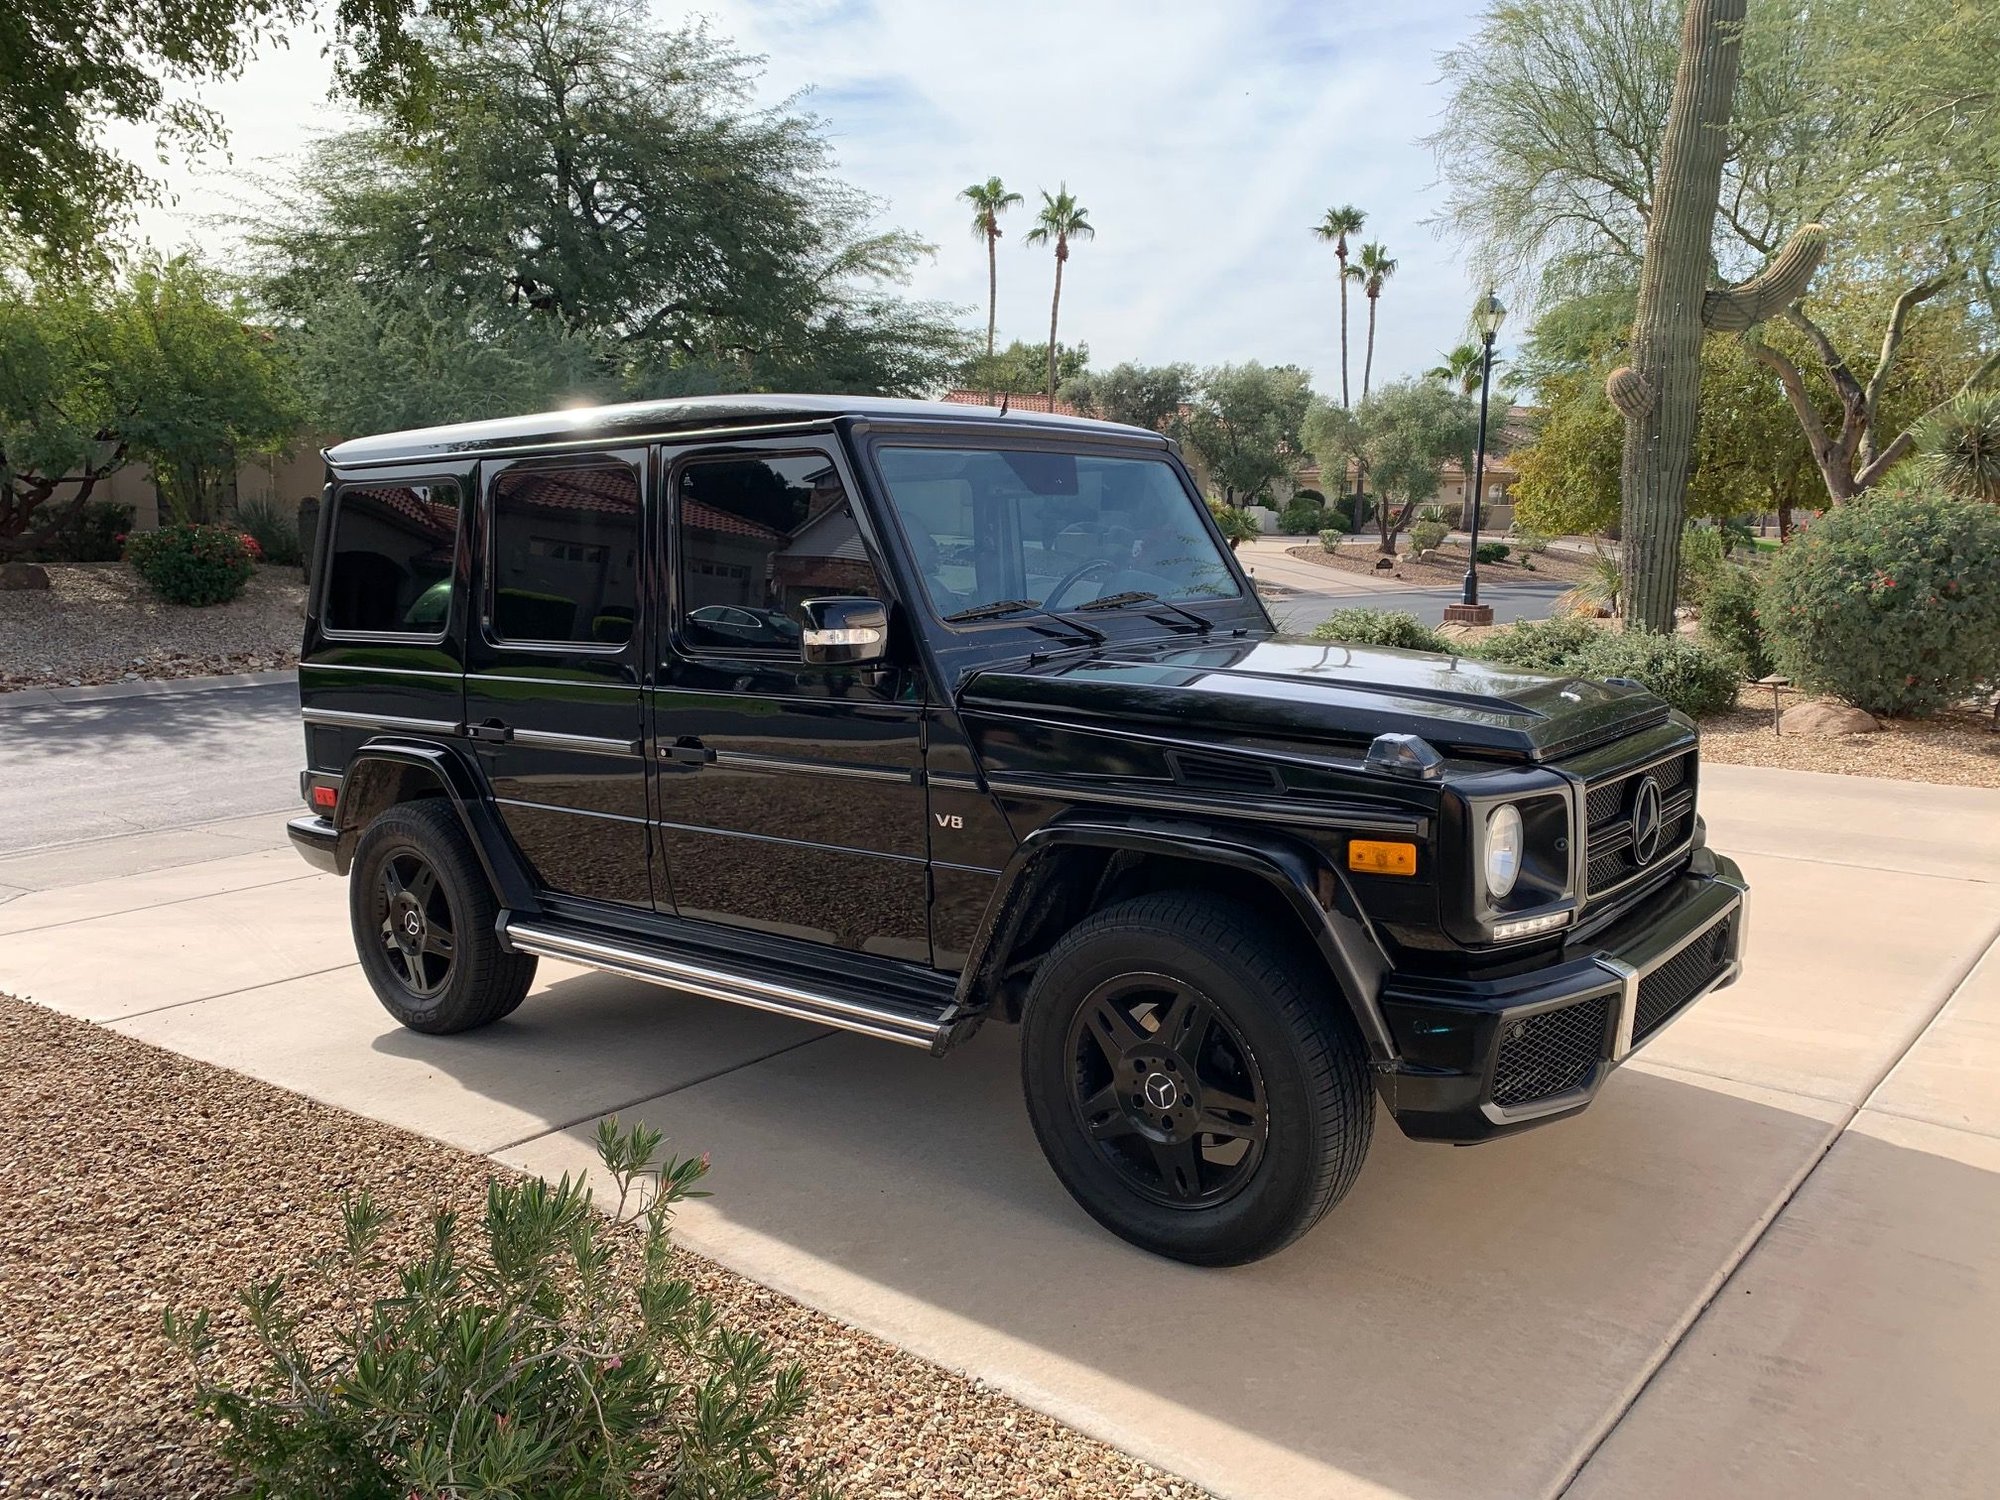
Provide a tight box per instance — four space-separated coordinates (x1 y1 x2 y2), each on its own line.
958 814 1396 1062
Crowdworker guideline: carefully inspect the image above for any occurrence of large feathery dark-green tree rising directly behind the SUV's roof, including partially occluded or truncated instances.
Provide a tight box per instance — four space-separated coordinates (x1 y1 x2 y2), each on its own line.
246 0 966 418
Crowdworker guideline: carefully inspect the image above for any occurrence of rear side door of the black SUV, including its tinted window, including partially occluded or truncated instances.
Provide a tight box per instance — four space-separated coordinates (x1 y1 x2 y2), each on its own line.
466 450 652 906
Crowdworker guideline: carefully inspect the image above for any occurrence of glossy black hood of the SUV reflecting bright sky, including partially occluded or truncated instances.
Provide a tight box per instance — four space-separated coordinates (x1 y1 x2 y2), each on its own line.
960 640 1668 760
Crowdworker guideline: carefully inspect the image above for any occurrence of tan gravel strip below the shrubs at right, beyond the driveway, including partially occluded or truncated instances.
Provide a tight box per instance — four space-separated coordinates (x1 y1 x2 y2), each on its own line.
1702 688 2000 786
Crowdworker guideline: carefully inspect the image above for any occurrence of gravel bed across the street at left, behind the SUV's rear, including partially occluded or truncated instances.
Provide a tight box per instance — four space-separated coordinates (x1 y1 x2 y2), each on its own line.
0 562 306 692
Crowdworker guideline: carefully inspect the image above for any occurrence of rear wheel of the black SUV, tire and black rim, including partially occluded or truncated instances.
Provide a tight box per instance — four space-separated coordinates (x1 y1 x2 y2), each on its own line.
348 798 534 1036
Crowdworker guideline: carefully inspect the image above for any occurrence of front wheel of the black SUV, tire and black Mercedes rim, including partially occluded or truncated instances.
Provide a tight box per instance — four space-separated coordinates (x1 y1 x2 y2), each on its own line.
1022 892 1374 1266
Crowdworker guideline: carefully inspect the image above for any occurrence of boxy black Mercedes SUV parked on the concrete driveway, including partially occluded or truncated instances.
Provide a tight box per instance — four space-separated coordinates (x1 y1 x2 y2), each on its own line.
290 396 1744 1264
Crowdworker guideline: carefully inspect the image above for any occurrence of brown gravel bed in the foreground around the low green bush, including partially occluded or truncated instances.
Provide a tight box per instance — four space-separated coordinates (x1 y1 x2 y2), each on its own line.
0 996 1204 1500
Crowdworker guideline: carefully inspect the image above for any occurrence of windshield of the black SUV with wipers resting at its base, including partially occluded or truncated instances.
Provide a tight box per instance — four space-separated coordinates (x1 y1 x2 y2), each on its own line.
876 448 1242 618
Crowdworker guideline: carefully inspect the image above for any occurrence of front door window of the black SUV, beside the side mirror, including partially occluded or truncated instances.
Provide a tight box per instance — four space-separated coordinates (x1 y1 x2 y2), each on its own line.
674 454 882 656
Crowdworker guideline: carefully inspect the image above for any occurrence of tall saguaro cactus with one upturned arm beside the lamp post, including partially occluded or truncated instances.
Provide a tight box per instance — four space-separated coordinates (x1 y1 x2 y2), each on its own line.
1604 0 1826 632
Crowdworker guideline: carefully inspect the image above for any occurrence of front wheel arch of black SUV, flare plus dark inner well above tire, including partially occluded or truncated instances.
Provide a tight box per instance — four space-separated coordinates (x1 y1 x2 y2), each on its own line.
960 816 1392 1062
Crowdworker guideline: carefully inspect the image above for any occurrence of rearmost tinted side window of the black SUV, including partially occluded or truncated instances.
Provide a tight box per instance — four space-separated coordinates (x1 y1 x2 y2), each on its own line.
322 480 458 636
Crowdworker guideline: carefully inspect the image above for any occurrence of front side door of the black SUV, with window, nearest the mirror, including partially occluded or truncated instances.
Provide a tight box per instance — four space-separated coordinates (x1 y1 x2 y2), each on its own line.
650 440 930 962
